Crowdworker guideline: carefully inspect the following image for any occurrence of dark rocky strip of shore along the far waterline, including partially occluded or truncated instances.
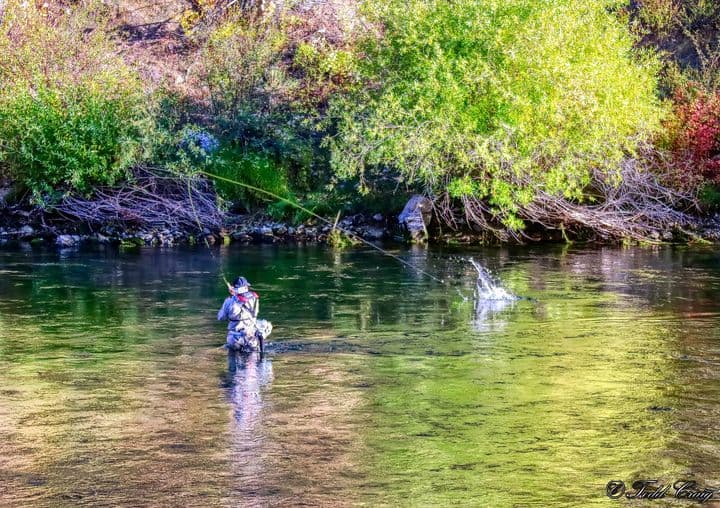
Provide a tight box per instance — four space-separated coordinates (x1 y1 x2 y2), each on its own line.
0 203 720 248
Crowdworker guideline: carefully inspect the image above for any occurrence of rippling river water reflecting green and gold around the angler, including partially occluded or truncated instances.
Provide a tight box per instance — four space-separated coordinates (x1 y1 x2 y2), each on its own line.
0 246 720 506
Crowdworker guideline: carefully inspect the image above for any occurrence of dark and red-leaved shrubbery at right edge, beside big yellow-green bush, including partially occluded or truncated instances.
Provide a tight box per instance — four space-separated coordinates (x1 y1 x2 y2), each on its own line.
624 0 720 209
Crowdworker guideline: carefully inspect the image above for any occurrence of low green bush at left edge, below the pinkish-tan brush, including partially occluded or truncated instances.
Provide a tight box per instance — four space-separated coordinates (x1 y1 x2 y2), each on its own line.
0 80 152 198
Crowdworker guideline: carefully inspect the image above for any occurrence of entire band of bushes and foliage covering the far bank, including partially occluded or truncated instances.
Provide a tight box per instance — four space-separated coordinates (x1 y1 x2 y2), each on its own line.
0 0 720 236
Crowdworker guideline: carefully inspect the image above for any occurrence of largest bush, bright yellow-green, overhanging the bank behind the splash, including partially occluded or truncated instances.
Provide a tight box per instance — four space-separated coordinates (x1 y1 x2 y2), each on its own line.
329 0 661 227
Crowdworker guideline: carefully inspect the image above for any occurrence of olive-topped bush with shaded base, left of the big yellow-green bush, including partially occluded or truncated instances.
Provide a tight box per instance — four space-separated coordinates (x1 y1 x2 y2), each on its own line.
195 8 356 198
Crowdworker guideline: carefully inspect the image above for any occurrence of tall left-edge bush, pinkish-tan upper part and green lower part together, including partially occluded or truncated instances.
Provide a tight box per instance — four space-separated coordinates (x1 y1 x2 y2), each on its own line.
0 0 152 195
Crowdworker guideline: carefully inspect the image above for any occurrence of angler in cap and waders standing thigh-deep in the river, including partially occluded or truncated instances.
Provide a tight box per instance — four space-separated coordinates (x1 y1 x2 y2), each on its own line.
218 277 260 351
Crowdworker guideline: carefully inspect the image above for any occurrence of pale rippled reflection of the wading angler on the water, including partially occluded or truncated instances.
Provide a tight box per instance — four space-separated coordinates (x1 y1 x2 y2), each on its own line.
225 351 273 432
